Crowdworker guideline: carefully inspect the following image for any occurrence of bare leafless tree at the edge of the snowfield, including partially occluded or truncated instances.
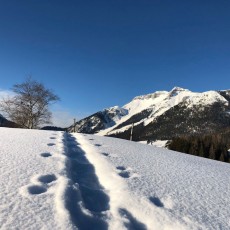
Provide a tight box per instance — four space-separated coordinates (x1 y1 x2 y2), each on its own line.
0 78 59 129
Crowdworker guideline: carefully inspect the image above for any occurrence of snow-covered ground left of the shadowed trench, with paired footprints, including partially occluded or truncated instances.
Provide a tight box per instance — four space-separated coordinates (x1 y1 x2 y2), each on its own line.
0 128 71 230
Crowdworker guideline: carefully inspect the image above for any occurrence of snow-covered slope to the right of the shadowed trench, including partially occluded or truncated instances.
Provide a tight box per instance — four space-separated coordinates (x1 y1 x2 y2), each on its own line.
74 134 230 230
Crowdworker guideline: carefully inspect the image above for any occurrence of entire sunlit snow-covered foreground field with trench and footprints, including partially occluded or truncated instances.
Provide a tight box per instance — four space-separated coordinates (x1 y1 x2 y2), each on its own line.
0 128 230 230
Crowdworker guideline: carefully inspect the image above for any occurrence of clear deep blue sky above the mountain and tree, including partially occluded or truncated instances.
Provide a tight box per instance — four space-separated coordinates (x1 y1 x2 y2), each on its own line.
0 0 230 126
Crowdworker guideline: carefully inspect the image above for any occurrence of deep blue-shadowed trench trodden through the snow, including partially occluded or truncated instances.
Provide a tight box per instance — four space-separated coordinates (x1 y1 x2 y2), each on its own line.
64 134 109 230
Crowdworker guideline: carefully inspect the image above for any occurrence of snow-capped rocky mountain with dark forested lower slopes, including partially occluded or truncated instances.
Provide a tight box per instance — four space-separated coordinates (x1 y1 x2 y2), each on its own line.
68 87 230 141
